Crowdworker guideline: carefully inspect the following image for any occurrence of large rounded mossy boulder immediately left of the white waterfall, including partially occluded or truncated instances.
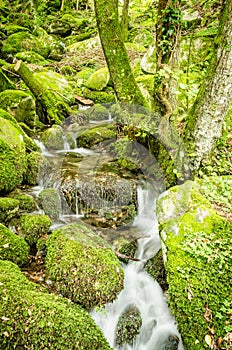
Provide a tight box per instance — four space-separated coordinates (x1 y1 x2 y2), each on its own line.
46 224 124 309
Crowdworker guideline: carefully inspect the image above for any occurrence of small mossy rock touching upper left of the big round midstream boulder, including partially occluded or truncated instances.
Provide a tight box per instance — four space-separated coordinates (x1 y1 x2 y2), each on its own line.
18 214 51 246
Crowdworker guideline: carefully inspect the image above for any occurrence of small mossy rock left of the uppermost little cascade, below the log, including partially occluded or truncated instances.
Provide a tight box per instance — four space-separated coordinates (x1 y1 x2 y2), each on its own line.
41 125 64 150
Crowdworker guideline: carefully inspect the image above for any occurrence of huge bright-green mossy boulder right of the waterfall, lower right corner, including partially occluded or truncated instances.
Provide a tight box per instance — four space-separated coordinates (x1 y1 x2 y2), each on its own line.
157 182 232 350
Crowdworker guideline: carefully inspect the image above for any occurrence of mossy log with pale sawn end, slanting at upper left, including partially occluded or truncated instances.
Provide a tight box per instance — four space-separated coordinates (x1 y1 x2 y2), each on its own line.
14 60 72 124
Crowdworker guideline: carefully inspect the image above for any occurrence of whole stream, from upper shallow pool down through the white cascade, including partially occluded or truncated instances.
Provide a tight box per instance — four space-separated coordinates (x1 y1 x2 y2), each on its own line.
32 119 183 350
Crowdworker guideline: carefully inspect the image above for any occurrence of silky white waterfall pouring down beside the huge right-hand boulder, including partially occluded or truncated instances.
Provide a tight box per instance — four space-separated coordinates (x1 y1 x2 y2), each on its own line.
91 184 183 350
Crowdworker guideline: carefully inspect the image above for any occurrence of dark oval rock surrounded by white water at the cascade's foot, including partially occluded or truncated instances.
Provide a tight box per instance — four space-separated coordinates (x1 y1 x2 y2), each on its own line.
115 305 142 347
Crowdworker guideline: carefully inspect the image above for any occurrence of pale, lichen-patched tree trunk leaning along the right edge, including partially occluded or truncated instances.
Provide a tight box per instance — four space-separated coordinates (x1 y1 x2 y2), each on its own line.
183 0 232 171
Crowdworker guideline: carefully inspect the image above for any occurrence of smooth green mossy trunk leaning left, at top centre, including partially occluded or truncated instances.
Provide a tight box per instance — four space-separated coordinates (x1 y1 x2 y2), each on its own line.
94 0 148 107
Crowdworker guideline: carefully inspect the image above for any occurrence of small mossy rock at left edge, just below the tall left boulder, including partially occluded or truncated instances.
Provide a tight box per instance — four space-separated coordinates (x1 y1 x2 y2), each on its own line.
0 197 20 223
